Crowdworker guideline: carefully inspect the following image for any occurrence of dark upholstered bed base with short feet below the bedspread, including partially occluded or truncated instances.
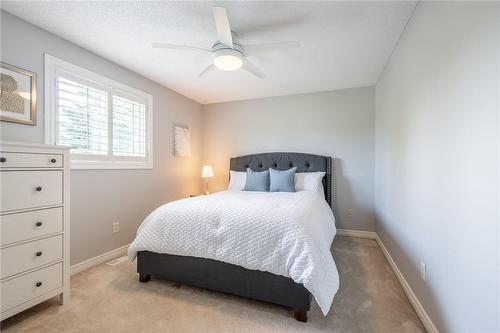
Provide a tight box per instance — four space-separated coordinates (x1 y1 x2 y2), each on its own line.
137 251 311 322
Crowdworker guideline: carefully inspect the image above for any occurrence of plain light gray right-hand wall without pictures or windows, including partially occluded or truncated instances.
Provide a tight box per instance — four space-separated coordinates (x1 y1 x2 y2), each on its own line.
375 2 500 332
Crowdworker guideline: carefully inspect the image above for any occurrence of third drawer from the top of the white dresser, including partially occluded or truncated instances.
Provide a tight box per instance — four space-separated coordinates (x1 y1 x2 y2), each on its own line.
0 207 63 246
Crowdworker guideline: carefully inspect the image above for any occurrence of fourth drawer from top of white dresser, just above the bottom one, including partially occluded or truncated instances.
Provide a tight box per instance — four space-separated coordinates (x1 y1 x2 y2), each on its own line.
0 235 62 279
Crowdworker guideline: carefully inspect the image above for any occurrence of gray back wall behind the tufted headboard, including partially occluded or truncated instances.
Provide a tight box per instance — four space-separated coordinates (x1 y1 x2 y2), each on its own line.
203 87 375 230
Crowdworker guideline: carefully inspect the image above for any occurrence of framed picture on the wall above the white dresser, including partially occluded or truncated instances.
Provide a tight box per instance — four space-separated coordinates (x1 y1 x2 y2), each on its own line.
0 62 36 125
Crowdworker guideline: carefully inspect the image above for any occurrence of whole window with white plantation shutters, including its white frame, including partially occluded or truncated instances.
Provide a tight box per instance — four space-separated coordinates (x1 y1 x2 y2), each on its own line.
45 55 153 169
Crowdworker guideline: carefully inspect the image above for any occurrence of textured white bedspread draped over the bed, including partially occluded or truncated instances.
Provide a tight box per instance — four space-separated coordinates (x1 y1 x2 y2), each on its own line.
128 191 339 315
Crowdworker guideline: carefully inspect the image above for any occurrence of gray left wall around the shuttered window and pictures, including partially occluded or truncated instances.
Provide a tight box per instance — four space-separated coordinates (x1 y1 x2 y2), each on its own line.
0 11 202 264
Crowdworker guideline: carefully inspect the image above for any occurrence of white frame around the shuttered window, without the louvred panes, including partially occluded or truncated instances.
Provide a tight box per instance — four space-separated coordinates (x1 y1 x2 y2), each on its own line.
45 54 154 169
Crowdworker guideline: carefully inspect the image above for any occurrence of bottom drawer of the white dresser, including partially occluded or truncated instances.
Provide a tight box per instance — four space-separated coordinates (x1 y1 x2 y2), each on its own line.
0 264 62 312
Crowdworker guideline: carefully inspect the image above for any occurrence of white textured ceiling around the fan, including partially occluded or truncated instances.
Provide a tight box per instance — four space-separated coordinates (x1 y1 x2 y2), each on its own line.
2 1 415 103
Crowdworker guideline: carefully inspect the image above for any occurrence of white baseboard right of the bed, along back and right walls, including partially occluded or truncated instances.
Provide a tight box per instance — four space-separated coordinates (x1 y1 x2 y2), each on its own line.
337 229 439 333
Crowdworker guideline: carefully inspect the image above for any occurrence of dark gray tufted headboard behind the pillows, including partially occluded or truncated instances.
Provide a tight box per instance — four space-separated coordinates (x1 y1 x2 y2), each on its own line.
229 153 332 207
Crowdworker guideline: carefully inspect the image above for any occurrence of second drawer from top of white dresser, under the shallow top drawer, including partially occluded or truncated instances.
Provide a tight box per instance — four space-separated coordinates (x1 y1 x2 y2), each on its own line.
1 171 63 212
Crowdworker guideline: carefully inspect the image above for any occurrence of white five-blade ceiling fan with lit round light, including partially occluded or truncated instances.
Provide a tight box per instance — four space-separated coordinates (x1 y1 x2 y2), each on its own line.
152 7 300 79
